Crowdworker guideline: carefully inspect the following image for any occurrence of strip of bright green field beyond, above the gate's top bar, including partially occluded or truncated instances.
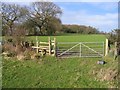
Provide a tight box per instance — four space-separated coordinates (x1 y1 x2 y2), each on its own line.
28 34 106 42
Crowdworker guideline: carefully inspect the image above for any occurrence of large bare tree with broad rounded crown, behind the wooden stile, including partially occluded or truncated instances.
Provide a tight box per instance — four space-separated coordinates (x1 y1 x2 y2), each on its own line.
29 2 62 35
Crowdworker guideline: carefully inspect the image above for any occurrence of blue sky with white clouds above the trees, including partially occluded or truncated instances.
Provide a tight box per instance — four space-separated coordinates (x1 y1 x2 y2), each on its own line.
1 0 118 32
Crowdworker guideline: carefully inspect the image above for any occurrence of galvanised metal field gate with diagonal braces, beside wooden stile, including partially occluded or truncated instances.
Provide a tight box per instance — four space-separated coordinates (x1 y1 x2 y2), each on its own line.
57 42 104 58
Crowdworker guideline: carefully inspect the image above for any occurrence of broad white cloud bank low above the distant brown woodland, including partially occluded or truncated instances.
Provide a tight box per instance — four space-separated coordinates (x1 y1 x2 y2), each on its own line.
61 11 118 32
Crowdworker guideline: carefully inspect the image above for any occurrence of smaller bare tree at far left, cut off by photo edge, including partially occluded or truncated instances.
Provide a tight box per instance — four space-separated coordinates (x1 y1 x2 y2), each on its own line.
2 3 28 35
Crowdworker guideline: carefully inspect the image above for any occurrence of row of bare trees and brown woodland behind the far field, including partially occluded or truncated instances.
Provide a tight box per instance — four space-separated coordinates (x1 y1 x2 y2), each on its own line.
2 2 100 36
